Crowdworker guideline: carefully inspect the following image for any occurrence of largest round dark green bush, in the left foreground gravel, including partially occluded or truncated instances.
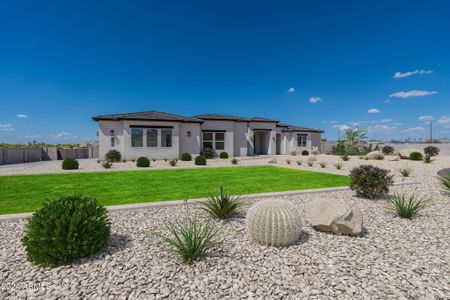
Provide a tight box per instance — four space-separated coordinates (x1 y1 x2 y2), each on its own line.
22 195 111 267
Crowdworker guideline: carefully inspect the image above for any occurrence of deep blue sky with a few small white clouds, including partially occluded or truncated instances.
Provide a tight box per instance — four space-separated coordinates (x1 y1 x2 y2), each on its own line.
0 0 450 143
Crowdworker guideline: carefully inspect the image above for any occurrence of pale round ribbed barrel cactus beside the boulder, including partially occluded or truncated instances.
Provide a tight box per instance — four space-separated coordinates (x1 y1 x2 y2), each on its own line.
247 200 302 247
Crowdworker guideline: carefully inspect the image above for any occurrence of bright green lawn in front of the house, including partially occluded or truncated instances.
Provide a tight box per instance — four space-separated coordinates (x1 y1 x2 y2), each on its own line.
0 166 348 214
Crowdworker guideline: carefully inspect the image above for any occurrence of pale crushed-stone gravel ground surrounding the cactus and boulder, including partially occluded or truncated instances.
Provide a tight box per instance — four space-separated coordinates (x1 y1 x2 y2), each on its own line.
0 156 450 299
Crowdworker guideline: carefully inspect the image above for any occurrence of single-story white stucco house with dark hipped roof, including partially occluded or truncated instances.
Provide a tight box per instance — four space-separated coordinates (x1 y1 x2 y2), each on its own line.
92 111 323 159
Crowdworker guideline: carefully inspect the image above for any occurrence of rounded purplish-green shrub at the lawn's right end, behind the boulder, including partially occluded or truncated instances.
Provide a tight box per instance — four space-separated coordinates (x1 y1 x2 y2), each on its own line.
350 165 394 199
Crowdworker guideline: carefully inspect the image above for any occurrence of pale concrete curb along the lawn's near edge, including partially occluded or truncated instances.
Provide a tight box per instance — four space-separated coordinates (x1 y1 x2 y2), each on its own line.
0 181 420 223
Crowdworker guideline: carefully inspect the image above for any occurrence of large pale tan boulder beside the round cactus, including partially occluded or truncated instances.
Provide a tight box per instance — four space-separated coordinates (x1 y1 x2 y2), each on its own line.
306 199 363 235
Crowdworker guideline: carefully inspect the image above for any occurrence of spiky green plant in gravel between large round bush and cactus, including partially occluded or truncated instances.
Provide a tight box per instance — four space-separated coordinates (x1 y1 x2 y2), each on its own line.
157 218 220 265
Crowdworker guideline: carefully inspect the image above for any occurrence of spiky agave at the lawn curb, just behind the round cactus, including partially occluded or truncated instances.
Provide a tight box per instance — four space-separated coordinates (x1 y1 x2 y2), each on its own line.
201 185 244 220
